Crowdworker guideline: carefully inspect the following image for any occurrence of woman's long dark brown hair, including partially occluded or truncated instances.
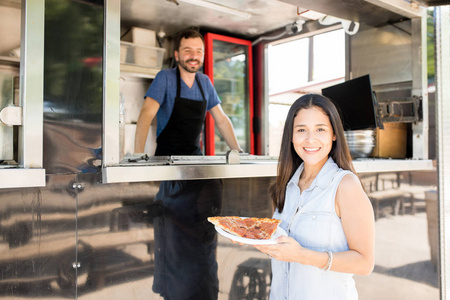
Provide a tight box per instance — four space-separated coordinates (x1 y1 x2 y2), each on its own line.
269 94 356 212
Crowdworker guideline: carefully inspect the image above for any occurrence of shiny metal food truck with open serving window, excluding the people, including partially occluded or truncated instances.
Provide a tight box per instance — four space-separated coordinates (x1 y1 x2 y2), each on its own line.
0 0 450 299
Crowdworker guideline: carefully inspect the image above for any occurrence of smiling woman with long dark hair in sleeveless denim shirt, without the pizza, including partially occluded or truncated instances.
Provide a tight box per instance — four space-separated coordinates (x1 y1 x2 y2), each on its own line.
255 94 375 300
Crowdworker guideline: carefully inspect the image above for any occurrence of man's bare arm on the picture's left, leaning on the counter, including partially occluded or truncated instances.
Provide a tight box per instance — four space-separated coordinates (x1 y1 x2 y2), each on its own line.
134 97 159 153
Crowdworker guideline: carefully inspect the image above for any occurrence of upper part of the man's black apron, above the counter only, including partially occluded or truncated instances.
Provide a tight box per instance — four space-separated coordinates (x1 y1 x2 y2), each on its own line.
155 68 206 156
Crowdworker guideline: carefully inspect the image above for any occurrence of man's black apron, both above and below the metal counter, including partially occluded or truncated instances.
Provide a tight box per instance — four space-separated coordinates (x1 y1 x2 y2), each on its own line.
153 68 222 300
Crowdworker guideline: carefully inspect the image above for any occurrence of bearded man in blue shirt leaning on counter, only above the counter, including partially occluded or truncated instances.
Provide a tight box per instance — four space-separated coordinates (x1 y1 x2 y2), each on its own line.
134 30 242 155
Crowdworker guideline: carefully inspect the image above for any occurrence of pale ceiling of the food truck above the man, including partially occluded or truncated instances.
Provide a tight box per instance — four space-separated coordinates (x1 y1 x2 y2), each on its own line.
121 0 432 39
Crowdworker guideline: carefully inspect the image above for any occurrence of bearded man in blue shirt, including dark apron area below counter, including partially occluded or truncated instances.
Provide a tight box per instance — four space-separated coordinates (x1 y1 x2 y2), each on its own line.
135 30 237 300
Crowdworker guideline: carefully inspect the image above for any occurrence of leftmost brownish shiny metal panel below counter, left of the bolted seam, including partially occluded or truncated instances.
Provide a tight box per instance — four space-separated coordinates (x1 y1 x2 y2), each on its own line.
0 176 76 298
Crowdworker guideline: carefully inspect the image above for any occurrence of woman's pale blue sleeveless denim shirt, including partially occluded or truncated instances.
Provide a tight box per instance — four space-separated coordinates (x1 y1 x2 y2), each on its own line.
270 157 358 300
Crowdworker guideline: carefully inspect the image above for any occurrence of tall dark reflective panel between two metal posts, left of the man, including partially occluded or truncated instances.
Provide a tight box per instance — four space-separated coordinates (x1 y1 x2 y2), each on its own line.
44 0 103 174
